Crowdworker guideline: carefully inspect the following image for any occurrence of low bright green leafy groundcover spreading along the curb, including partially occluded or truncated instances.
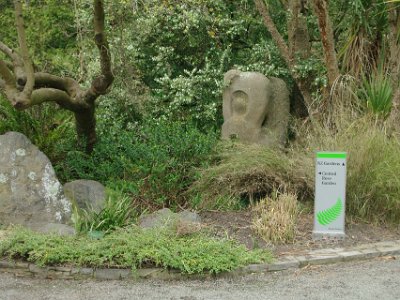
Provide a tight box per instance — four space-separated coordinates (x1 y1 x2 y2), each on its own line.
0 226 271 274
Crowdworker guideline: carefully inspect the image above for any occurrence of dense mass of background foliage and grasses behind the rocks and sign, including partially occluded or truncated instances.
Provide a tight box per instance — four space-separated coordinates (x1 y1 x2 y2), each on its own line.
0 0 400 227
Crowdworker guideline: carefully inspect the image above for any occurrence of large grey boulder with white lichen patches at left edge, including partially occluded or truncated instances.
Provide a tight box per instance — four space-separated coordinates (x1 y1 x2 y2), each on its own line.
0 132 71 229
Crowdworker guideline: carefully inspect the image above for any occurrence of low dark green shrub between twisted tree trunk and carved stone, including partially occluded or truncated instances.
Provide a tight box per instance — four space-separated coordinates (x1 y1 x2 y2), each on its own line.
56 121 217 207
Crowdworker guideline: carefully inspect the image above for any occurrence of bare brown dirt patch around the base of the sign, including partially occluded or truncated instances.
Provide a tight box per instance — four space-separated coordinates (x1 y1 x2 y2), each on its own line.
201 211 400 256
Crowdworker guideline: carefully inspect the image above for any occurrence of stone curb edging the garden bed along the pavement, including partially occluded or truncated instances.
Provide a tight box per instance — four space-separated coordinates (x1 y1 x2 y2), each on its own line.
0 240 400 280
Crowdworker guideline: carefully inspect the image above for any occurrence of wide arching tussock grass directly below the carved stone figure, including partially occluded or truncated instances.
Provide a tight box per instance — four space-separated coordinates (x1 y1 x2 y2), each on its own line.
190 142 313 208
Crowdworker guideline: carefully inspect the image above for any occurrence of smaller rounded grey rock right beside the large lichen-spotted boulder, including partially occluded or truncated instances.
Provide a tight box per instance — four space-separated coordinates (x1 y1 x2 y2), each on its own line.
63 179 106 212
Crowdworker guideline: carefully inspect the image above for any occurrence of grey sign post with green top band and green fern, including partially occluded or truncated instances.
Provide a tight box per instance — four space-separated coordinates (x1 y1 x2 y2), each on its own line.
313 152 347 239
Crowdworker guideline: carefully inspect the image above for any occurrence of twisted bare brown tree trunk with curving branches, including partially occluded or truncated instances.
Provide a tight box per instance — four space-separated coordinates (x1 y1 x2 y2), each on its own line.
0 0 114 152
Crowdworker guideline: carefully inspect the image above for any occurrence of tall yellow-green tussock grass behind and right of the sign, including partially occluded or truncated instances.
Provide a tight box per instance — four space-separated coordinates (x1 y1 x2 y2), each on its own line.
296 112 400 223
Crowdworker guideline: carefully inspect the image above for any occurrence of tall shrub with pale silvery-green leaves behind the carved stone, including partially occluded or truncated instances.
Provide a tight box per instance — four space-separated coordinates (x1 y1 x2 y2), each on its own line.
111 0 288 129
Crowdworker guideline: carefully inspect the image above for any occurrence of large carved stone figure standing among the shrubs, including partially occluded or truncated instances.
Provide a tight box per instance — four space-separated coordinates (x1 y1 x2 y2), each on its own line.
222 70 290 147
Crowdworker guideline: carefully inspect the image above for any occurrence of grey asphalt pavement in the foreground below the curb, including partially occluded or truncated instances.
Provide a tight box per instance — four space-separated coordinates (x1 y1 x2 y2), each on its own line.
0 257 400 300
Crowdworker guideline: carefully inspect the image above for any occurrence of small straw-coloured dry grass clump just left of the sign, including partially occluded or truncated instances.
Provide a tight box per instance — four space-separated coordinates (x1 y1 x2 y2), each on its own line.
252 194 299 243
